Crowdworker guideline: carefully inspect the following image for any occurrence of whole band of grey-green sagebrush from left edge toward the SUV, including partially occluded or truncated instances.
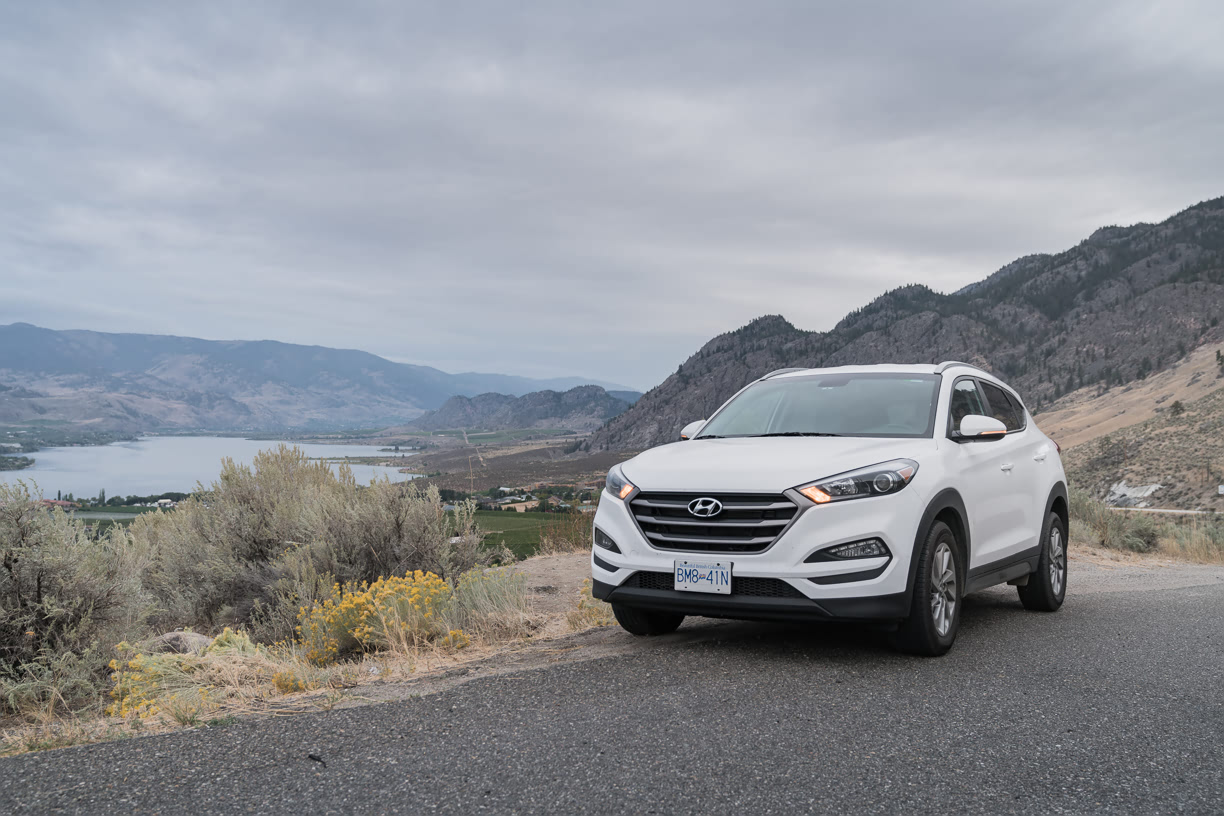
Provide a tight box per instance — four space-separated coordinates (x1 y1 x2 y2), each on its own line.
0 445 509 717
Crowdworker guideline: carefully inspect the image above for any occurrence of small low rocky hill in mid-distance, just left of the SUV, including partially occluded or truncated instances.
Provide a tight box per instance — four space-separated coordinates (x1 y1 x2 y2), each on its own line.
408 385 640 431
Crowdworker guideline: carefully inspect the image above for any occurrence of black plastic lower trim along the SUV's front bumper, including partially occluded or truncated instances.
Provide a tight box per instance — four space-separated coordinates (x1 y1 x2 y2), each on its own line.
591 580 909 621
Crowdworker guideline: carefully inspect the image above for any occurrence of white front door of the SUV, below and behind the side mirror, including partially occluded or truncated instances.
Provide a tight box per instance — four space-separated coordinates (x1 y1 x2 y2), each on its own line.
947 377 1020 570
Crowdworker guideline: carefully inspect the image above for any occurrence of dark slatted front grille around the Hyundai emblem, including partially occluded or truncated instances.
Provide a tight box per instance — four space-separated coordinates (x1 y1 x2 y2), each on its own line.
629 493 799 553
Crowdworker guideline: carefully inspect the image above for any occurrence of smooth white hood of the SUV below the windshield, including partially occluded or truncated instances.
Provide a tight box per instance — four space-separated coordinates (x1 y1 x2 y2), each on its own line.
622 437 935 493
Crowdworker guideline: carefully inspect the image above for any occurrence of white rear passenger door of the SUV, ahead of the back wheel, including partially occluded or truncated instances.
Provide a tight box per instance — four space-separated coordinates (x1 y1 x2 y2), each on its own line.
978 379 1049 559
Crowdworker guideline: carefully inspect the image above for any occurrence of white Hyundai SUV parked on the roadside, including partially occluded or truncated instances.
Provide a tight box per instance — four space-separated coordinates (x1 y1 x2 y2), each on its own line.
591 362 1067 655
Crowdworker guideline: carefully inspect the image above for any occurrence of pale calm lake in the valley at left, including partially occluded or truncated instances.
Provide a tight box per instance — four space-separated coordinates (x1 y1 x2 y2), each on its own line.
0 437 412 498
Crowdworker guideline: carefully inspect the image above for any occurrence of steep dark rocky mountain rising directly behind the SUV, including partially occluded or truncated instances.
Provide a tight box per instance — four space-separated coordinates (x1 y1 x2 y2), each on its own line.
588 198 1224 450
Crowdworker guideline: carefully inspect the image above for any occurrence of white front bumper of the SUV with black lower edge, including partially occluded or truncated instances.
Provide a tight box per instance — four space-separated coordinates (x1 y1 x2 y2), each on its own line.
591 491 924 620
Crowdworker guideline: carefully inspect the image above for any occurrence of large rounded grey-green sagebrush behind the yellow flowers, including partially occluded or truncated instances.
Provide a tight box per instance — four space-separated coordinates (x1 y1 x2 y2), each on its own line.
131 445 506 642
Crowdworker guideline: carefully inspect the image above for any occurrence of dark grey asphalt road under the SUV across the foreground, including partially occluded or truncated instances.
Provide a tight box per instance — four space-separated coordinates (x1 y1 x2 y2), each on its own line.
0 569 1224 816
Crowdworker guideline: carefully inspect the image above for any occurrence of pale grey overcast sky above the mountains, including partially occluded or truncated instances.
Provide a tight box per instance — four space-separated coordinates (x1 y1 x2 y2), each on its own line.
0 0 1224 389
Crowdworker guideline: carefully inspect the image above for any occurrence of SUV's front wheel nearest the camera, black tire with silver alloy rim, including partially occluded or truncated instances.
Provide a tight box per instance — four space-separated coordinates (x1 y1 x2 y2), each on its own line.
892 521 965 657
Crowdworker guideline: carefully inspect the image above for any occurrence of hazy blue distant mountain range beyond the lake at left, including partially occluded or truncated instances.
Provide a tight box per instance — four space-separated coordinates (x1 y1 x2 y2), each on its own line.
0 323 629 432
